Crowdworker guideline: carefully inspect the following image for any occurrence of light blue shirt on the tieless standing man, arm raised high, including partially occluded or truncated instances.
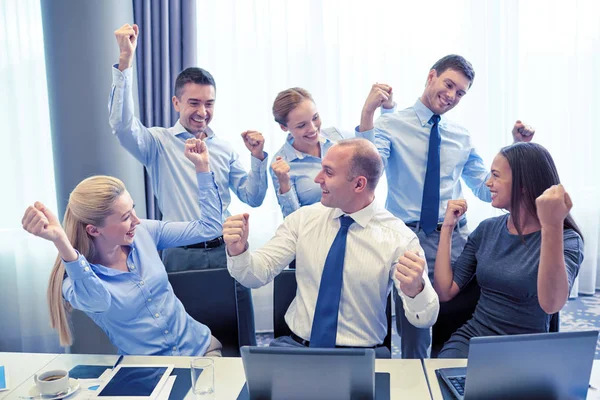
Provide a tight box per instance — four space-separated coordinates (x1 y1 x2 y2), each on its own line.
108 67 268 222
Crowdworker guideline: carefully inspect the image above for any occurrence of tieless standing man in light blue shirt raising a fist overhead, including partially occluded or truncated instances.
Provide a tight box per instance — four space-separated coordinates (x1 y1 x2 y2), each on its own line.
109 24 267 345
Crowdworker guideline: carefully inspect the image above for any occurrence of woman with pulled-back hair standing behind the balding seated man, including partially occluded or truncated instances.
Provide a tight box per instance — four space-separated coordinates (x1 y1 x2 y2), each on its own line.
270 84 395 218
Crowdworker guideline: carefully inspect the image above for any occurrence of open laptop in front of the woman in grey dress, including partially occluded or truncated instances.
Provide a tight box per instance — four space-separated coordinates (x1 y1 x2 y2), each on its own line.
436 331 598 400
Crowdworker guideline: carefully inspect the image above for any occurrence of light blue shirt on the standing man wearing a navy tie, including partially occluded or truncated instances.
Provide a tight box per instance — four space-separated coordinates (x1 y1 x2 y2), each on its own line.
357 99 492 223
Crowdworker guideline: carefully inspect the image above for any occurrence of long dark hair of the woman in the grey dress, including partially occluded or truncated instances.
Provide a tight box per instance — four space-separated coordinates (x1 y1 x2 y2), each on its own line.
500 142 583 239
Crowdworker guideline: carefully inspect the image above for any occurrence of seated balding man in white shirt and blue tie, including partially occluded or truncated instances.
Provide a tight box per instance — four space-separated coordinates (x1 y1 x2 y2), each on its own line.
223 139 439 358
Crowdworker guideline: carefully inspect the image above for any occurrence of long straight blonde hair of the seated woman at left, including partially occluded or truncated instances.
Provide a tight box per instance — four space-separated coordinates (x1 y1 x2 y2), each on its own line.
47 175 125 346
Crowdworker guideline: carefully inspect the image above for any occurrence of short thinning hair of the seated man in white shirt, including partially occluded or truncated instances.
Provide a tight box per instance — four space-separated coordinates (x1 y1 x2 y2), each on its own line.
336 138 383 190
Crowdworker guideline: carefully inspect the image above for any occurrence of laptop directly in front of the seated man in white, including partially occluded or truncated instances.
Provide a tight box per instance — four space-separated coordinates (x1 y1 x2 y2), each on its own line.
241 346 375 400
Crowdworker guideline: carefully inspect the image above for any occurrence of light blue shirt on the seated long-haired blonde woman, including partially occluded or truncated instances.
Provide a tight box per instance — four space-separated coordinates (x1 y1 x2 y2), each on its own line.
62 172 222 356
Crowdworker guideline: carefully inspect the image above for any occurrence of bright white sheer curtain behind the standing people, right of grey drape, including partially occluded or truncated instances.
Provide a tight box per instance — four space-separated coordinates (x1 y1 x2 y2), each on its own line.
198 0 600 330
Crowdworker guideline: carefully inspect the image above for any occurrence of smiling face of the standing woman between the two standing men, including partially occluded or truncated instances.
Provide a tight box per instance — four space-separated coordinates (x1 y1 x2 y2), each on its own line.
281 99 321 153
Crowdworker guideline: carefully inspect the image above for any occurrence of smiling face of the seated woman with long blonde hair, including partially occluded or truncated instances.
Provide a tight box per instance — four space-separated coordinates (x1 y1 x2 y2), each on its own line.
86 191 140 249
